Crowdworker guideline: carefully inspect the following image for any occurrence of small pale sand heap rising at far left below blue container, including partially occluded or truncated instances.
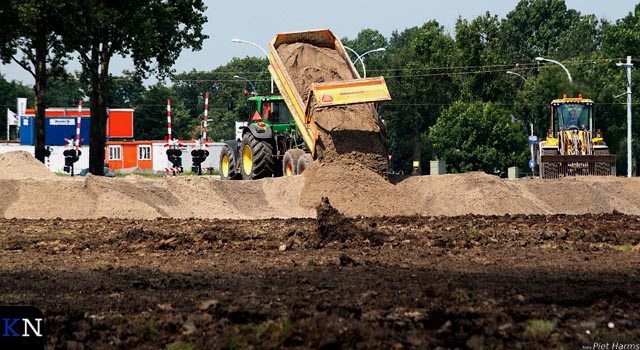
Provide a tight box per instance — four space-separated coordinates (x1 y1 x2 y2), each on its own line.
0 151 56 180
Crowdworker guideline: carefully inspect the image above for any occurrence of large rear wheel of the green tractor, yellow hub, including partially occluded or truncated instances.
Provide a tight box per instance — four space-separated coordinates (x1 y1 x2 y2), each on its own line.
240 132 274 180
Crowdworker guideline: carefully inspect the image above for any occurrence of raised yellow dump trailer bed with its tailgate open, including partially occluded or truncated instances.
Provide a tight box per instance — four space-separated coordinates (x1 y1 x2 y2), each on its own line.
269 29 391 157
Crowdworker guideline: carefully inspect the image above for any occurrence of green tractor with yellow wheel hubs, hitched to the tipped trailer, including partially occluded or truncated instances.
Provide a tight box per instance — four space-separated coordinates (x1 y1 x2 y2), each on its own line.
220 95 313 180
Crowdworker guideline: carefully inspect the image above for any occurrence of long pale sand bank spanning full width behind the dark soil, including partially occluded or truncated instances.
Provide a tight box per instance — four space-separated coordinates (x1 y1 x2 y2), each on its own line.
0 152 640 220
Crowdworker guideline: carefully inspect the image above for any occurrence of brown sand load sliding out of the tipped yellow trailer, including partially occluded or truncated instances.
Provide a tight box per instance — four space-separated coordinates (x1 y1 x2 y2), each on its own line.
277 40 387 174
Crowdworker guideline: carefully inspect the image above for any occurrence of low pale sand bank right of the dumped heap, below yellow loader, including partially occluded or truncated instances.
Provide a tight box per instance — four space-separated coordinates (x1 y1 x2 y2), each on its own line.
397 172 640 216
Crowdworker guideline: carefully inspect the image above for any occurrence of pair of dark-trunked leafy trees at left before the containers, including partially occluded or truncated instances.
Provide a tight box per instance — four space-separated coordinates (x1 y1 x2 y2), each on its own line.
0 0 207 175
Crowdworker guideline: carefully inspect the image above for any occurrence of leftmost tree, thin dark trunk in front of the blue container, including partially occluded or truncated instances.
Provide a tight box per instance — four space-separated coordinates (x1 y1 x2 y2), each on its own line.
0 0 68 162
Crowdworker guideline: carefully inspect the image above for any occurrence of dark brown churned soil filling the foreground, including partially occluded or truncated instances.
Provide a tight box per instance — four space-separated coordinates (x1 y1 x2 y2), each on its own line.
0 203 640 349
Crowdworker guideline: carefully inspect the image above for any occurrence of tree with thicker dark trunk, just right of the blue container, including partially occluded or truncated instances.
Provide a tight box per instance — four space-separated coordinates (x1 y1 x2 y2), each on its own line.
61 0 207 175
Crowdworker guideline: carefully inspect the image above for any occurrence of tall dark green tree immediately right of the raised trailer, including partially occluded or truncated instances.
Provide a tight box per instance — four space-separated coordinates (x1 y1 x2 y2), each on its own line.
381 21 457 171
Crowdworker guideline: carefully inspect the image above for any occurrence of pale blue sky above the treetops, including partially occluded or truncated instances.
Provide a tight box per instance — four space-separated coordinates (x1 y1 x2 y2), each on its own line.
0 0 637 85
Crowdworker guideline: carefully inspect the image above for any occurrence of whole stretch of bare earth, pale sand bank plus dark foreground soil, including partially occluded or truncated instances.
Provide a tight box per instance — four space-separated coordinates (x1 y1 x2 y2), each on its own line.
0 153 640 349
